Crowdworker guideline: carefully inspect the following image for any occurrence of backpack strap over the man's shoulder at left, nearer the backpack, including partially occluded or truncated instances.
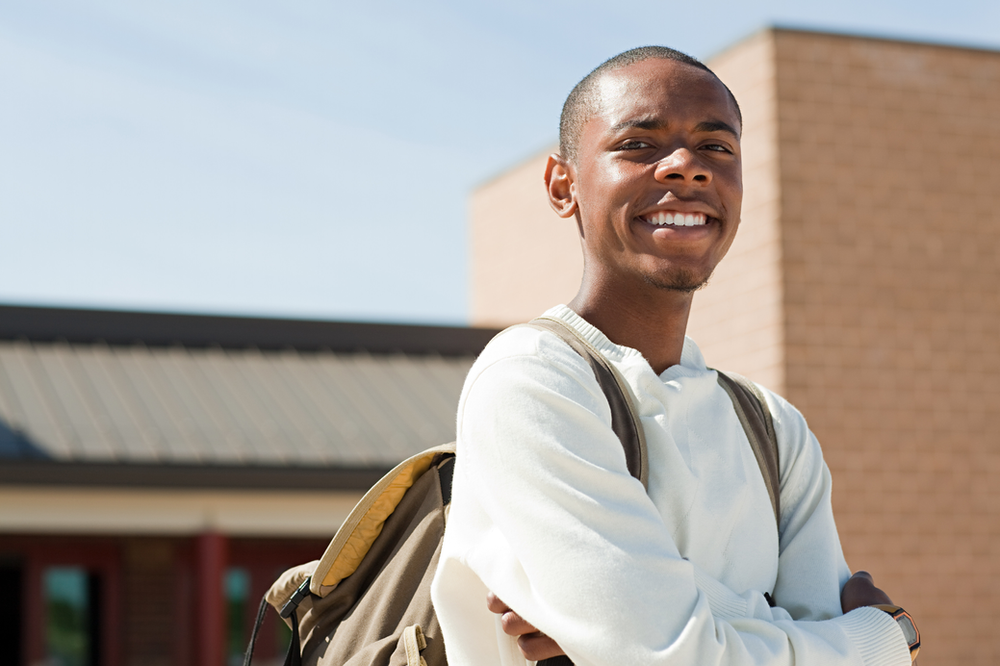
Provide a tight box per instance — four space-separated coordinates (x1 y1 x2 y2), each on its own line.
526 317 649 489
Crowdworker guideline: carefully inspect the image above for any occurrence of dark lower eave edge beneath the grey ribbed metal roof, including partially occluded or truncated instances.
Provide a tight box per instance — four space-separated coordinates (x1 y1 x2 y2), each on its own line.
0 459 390 491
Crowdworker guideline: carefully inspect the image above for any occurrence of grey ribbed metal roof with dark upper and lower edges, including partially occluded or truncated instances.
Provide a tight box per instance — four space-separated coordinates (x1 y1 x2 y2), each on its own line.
0 307 493 488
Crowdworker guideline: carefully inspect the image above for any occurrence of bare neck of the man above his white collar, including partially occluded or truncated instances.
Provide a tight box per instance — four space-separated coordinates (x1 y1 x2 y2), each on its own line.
569 286 694 374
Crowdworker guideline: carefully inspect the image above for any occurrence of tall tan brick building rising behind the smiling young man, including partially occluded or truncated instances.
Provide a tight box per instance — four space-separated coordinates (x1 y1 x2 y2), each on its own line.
471 29 1000 666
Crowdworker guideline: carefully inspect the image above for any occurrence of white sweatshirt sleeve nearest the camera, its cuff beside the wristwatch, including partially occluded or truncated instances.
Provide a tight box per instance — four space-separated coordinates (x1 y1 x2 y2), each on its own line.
446 332 910 666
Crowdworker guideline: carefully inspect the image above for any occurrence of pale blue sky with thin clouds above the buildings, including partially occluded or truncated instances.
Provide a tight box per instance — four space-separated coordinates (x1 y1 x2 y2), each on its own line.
0 0 1000 324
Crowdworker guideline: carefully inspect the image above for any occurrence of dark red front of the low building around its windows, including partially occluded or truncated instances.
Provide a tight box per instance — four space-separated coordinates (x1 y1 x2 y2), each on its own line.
0 533 332 666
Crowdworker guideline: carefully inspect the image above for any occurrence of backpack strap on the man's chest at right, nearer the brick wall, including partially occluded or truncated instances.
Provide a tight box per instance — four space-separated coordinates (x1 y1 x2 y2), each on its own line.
716 370 781 534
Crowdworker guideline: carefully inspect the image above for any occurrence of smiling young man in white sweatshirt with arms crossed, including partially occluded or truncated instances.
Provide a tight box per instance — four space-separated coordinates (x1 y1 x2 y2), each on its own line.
432 47 911 666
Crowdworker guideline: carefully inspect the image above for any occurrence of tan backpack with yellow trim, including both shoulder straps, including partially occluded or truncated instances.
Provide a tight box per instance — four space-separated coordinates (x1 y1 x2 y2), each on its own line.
243 317 780 666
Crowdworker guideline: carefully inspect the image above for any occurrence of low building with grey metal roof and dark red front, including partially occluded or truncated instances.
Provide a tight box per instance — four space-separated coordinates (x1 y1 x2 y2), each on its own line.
0 307 495 666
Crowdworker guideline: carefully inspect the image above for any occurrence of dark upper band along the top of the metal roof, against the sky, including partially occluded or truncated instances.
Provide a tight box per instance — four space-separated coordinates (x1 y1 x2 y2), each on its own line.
0 305 497 356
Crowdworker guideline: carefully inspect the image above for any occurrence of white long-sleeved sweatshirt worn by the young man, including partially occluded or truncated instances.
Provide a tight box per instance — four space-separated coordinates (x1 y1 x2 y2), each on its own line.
431 306 910 666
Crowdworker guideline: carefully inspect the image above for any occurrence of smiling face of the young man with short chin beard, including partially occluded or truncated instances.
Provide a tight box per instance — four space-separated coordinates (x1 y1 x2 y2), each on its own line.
568 59 743 291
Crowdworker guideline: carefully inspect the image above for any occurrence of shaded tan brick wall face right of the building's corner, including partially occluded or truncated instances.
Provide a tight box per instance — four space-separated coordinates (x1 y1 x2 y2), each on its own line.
772 31 1000 666
